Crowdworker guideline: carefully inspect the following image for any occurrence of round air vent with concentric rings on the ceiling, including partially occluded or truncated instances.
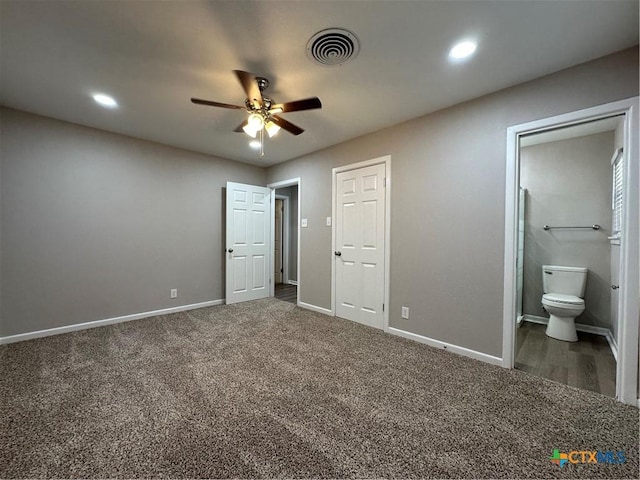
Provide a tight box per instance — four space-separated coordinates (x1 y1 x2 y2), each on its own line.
307 28 360 66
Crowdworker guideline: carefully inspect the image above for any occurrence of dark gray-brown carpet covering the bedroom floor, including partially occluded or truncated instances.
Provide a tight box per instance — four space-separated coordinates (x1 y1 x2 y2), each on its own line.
0 299 638 478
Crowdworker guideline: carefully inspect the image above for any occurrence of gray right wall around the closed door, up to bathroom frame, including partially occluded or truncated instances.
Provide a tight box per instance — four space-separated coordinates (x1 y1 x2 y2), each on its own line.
268 47 638 356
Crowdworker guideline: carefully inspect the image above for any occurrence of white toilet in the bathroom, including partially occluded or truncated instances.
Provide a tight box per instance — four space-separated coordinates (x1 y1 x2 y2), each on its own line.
542 265 588 342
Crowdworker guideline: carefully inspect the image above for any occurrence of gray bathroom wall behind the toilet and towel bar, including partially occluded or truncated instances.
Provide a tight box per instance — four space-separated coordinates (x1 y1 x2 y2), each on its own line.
520 131 614 329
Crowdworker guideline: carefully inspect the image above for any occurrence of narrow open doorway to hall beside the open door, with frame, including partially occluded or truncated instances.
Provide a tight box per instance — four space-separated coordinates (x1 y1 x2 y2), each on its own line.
269 179 300 305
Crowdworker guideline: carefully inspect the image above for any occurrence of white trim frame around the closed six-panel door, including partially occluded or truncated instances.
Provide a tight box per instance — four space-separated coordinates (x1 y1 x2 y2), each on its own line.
331 155 391 332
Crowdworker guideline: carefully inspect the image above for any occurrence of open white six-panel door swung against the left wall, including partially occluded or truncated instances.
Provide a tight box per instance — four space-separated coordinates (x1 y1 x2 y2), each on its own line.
225 182 271 304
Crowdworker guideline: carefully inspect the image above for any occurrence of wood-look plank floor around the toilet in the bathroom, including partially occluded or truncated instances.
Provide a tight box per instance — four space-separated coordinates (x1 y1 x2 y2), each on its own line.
516 322 616 397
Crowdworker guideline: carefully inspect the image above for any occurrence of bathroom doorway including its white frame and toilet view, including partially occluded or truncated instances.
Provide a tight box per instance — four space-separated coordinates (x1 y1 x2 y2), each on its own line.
503 98 638 404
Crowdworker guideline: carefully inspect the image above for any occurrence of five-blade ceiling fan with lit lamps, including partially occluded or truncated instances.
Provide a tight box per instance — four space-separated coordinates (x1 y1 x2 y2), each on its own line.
191 70 322 144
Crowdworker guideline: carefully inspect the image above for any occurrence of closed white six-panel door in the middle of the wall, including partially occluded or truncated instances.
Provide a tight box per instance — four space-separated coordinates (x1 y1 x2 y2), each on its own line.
334 164 385 329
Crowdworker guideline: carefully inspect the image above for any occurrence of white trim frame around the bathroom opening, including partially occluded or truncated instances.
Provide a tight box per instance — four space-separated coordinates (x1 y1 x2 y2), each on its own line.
502 97 640 407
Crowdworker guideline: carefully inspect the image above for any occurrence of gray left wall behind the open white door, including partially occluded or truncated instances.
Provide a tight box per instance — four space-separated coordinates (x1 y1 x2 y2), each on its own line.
0 109 266 336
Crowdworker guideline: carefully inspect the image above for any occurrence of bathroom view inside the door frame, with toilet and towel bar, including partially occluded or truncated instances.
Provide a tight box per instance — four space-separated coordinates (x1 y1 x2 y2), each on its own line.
515 115 624 397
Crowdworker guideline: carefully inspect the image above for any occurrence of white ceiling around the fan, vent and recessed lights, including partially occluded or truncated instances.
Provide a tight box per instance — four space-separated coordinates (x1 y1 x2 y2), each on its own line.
0 0 638 165
